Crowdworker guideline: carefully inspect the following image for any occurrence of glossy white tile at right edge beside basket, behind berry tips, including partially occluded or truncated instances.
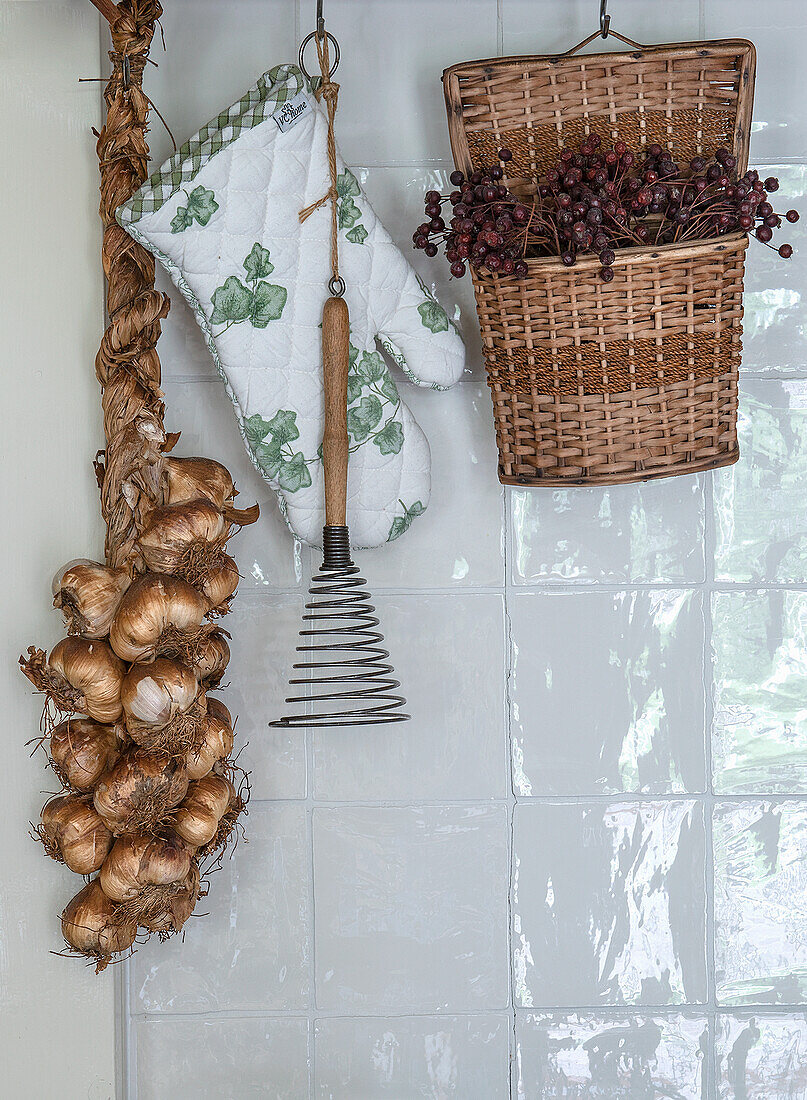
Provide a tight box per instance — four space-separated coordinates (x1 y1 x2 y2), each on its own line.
742 164 807 374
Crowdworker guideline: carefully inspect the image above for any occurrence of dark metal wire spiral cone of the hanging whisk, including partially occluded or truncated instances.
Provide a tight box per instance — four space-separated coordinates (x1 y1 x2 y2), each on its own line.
269 527 409 728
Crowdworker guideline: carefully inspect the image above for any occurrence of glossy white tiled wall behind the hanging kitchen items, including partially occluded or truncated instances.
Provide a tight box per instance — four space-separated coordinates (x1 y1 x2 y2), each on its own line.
123 0 807 1100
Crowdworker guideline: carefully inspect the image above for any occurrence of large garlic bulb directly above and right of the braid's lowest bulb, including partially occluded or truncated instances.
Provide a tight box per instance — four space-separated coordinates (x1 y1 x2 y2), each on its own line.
98 836 191 902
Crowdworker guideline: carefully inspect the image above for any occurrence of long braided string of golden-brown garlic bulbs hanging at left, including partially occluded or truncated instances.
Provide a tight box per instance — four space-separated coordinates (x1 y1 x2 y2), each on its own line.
21 0 252 971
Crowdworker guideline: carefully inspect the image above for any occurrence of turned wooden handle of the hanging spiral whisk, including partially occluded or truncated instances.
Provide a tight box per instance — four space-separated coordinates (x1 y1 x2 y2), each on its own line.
322 298 351 527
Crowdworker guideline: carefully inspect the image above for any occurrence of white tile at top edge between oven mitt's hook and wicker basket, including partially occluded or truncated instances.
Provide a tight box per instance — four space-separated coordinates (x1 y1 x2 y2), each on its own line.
323 0 497 167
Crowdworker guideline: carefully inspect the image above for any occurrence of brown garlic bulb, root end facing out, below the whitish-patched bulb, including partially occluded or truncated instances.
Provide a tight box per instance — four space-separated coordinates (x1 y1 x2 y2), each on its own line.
92 749 188 836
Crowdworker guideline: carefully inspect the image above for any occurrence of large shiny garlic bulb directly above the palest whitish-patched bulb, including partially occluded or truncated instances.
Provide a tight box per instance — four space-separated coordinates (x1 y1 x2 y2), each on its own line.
109 573 208 661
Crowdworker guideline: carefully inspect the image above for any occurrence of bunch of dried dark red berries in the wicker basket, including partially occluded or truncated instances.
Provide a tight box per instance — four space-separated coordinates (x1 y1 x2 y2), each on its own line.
412 134 798 283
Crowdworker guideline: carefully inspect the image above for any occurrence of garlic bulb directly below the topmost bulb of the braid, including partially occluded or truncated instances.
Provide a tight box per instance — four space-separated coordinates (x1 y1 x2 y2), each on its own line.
139 501 230 574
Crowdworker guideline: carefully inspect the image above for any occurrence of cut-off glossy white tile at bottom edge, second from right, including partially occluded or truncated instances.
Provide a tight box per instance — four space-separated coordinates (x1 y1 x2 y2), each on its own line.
516 1012 708 1100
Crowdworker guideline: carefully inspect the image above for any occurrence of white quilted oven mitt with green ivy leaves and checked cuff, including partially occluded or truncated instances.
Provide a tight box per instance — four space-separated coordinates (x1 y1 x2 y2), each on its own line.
117 65 465 548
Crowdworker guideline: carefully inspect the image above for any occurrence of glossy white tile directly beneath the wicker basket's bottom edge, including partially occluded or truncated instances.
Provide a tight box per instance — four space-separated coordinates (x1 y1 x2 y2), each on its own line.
510 475 704 584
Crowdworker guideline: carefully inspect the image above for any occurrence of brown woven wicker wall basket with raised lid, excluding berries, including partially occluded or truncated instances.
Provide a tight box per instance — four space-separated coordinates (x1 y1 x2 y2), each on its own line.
443 40 755 485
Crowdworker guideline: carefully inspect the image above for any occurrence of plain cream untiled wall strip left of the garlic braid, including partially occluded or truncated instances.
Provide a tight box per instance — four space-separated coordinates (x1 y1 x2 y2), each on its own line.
0 0 114 1100
